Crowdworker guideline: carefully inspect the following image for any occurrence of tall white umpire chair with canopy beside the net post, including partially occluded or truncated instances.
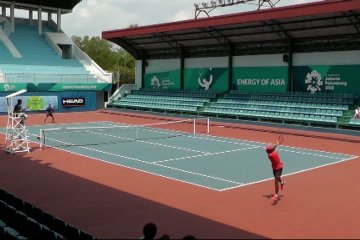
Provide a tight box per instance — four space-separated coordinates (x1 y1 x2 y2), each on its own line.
5 89 30 154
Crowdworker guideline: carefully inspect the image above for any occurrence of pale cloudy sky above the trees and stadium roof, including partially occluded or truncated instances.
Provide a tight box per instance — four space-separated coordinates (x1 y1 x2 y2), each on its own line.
55 0 319 37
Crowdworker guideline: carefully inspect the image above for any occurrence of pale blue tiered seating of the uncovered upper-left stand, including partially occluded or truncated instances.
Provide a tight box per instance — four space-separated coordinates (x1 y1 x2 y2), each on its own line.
0 23 97 83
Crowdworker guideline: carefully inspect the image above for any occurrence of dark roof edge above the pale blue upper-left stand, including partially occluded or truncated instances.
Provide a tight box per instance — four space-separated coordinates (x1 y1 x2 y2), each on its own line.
0 0 81 10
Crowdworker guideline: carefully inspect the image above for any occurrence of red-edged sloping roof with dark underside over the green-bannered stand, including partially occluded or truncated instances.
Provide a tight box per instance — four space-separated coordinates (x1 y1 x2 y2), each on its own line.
102 0 360 59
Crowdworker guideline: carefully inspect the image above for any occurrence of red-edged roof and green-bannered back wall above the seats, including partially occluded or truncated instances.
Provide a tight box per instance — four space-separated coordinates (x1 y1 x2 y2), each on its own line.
103 0 360 93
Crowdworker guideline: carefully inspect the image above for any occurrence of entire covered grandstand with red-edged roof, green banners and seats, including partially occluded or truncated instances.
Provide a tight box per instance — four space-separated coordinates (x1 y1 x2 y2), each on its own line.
102 0 360 127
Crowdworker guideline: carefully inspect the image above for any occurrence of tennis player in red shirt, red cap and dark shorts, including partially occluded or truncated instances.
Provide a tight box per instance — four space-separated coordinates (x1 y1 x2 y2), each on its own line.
265 144 285 202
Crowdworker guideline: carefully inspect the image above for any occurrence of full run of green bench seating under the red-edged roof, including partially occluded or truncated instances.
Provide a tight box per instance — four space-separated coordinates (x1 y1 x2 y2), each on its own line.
111 89 360 125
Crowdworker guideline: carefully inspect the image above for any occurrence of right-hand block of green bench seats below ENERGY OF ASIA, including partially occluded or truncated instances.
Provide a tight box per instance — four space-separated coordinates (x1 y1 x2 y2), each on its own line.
204 91 355 123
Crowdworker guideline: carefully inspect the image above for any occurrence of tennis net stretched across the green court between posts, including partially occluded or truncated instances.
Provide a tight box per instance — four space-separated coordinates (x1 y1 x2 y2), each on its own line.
38 118 210 149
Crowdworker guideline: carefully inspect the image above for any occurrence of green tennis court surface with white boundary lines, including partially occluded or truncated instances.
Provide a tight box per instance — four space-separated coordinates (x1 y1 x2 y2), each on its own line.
3 122 356 191
